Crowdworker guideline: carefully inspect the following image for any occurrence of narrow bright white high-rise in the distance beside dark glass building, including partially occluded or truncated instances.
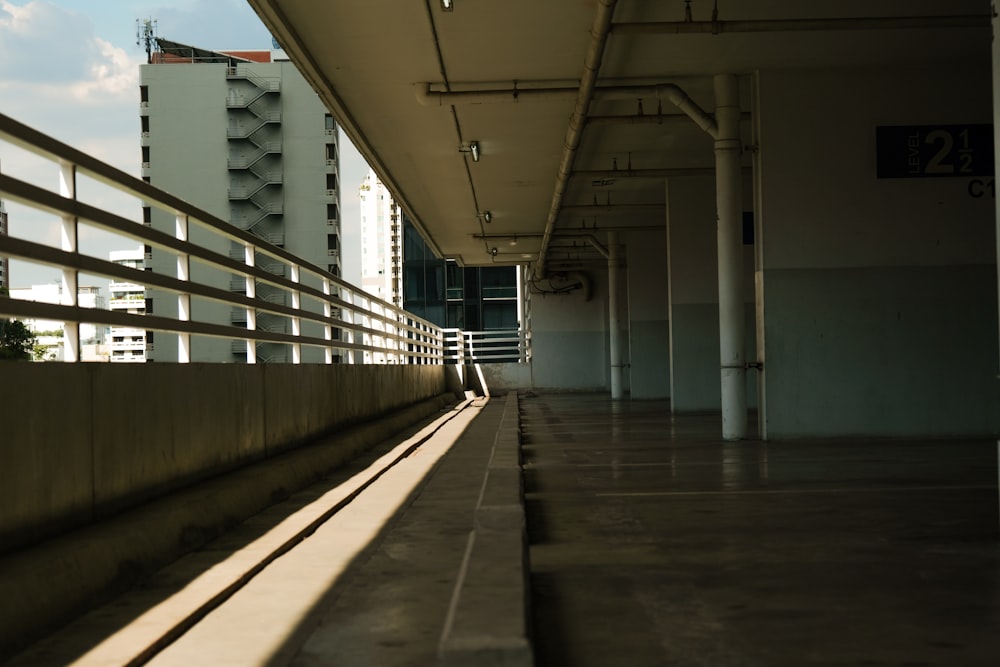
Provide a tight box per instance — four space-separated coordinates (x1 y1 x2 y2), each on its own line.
358 169 403 306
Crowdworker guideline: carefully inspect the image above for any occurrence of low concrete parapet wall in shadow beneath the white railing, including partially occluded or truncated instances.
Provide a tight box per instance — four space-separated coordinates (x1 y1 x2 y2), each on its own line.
0 363 448 551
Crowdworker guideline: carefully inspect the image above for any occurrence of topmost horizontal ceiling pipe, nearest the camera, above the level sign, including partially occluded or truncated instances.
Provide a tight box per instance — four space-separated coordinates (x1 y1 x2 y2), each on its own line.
612 14 990 35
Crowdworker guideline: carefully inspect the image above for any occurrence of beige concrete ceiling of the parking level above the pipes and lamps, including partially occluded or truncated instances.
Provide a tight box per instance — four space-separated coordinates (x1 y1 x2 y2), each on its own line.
249 0 990 268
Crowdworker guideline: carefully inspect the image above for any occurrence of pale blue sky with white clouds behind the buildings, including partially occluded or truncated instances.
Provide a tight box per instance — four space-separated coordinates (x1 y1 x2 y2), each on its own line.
0 0 368 287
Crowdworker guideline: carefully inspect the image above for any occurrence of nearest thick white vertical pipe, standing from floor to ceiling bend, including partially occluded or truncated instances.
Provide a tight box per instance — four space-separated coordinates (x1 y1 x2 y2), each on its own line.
714 74 747 440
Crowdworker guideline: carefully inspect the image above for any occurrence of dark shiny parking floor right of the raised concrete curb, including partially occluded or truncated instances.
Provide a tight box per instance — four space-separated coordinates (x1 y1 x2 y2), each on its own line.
521 395 1000 667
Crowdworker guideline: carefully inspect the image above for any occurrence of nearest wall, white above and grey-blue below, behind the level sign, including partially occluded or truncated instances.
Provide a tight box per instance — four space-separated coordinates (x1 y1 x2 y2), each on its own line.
758 67 1000 438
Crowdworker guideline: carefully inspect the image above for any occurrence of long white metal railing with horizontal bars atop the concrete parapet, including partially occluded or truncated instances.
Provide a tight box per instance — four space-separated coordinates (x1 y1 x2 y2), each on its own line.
0 114 444 364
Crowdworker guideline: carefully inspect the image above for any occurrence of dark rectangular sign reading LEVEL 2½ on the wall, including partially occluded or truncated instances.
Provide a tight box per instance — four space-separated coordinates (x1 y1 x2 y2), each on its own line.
875 124 993 178
